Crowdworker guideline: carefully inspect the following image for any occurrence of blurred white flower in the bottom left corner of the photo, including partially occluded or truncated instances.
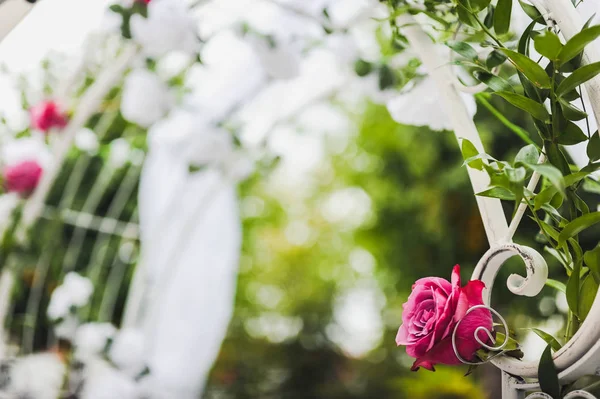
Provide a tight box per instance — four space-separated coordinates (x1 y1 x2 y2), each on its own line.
6 353 65 399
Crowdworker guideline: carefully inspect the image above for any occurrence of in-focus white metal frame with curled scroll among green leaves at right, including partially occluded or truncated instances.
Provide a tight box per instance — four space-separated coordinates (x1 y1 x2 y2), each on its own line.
397 0 600 399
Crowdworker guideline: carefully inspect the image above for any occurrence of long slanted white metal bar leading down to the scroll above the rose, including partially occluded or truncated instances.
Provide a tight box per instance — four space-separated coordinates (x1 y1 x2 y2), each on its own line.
397 14 508 246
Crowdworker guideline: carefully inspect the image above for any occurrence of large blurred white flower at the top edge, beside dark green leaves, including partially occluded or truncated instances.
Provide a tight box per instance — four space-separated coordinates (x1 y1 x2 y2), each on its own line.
131 0 200 58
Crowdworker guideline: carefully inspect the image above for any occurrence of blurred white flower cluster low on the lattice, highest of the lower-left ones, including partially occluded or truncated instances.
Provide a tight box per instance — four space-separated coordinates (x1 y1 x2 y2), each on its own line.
48 272 94 320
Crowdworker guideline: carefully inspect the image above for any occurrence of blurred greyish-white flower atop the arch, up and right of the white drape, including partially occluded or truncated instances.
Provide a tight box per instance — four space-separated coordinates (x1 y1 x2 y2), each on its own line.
247 33 302 79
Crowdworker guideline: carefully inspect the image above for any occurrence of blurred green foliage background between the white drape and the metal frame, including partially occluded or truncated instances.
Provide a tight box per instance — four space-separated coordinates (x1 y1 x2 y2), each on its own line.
205 97 561 398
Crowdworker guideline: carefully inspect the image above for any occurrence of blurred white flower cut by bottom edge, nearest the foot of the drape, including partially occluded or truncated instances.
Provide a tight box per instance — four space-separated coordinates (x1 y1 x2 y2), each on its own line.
81 359 139 399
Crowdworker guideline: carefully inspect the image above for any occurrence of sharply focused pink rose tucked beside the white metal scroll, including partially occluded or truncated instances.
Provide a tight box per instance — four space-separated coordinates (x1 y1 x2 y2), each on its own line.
396 265 492 371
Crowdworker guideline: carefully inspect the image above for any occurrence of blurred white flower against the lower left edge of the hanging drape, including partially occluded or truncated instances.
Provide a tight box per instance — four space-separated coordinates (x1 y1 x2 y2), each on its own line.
108 328 146 378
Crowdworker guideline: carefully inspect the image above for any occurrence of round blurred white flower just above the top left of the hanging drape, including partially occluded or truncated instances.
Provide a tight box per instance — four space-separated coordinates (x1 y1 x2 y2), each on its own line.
121 69 173 127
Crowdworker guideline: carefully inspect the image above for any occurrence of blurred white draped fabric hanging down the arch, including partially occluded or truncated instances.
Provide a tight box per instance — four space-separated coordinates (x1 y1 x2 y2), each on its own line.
139 123 241 399
